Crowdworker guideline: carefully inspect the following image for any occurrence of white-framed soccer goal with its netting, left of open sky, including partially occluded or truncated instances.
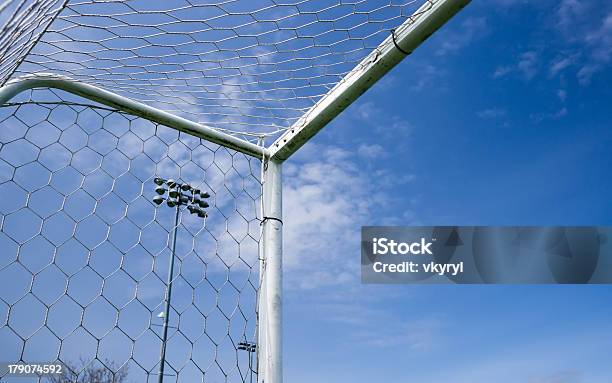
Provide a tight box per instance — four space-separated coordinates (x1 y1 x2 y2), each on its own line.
0 0 469 383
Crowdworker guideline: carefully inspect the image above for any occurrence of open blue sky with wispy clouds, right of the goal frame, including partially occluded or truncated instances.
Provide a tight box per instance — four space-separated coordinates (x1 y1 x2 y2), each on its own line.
285 0 612 383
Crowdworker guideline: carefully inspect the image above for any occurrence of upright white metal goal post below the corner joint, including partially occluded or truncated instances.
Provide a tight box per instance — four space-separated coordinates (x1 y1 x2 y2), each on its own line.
258 160 283 383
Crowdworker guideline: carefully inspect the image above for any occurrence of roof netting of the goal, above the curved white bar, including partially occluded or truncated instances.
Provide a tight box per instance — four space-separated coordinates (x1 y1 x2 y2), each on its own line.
0 0 432 142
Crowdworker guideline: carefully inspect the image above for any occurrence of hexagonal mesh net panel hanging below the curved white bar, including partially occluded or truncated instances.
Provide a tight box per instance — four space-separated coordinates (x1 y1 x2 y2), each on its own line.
0 90 262 382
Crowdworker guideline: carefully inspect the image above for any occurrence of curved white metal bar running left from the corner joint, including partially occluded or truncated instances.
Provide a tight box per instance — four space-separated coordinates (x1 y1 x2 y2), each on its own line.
0 74 268 159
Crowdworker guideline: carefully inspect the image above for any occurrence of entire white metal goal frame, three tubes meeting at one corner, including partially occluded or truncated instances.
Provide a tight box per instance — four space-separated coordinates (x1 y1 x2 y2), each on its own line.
0 0 469 383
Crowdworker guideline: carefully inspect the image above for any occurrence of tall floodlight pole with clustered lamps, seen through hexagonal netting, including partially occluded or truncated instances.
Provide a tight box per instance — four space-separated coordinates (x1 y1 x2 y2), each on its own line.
153 177 210 383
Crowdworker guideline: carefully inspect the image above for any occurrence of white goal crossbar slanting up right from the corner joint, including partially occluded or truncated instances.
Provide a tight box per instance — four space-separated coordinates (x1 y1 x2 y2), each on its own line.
269 0 470 161
